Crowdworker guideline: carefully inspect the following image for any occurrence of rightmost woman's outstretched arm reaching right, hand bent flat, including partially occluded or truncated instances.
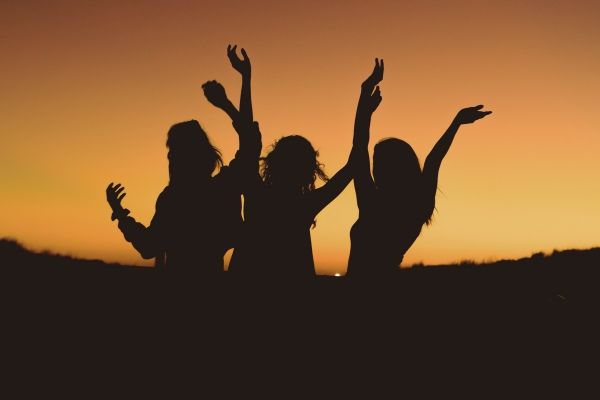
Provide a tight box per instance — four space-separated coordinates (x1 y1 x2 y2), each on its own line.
423 105 492 215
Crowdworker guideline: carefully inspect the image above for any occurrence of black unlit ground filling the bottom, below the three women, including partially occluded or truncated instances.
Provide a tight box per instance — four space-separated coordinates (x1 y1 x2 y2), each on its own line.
0 241 600 397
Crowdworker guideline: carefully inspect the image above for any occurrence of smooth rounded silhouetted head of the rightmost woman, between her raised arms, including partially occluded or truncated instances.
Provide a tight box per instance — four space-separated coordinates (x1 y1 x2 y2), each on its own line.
373 138 422 193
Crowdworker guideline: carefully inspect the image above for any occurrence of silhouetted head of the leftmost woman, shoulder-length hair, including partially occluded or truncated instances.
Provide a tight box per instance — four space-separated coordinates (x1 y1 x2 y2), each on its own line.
167 120 223 182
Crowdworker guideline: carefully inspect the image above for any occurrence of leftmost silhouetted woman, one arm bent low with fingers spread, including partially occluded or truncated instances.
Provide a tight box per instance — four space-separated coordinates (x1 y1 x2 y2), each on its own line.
106 54 255 276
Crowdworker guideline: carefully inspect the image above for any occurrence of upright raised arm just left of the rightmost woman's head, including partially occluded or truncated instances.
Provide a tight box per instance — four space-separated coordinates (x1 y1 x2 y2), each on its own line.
351 59 383 209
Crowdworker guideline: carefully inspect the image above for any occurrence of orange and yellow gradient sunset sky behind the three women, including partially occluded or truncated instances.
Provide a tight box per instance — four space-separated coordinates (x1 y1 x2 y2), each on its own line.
0 0 600 273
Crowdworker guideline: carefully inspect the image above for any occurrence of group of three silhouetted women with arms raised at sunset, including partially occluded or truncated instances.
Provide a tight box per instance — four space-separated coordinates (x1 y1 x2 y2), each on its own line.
106 46 491 279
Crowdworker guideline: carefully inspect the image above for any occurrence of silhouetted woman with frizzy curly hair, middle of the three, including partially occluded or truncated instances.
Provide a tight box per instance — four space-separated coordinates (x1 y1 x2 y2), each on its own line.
209 46 352 280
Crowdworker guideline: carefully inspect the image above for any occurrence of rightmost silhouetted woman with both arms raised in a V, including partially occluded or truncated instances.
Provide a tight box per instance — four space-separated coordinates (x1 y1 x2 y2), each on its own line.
348 59 491 277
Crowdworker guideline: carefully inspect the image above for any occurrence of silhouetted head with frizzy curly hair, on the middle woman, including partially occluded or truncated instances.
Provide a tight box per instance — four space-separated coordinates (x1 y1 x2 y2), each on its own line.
261 135 328 193
